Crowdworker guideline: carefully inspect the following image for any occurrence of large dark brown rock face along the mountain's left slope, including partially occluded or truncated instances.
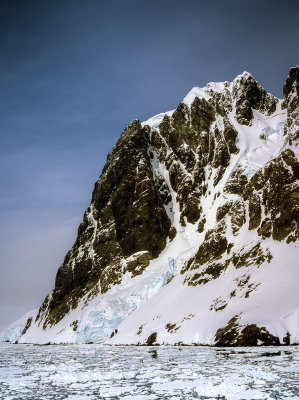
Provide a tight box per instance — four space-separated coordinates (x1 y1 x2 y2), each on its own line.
43 121 171 324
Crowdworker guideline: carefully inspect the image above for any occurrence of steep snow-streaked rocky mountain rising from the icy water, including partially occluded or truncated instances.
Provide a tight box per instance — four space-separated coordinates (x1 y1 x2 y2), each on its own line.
2 66 299 346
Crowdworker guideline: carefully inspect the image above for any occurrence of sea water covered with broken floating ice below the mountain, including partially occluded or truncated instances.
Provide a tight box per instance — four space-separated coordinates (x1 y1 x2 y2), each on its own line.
0 343 299 400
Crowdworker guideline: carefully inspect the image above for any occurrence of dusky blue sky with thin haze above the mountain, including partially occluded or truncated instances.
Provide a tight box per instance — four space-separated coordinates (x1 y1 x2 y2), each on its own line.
0 0 299 330
